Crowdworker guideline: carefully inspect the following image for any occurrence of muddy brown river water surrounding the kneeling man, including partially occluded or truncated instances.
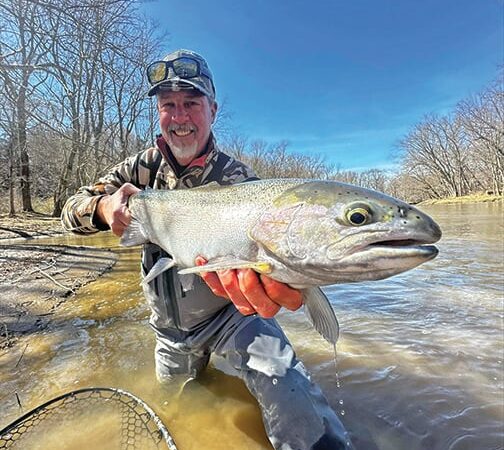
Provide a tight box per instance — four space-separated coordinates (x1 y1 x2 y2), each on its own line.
0 204 504 450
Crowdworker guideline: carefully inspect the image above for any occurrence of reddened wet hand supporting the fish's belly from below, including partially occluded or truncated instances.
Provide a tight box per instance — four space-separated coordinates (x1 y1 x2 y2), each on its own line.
196 256 303 318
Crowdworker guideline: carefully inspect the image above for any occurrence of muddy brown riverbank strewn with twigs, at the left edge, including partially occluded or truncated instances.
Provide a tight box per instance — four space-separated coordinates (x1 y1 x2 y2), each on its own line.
0 213 118 349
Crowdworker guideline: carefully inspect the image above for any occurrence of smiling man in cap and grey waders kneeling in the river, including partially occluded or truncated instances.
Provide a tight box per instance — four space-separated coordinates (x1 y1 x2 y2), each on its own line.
62 50 352 450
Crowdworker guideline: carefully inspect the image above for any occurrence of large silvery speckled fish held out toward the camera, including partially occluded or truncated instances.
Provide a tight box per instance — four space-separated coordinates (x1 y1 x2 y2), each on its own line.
121 179 441 344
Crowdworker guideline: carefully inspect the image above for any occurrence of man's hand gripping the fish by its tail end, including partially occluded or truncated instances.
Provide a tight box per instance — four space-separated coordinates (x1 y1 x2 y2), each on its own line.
95 183 140 236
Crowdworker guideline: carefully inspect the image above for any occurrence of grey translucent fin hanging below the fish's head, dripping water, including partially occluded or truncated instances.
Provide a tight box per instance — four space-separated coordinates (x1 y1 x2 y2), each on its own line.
302 287 339 345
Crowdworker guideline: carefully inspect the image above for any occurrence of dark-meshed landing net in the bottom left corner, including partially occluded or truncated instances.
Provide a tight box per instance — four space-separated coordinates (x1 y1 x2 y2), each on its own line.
0 388 177 450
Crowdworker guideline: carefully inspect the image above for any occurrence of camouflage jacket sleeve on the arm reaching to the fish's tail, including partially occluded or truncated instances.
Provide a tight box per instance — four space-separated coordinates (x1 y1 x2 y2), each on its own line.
61 149 155 234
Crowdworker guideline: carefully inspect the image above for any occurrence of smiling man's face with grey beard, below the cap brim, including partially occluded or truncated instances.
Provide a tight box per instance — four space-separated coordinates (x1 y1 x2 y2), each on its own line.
157 90 217 166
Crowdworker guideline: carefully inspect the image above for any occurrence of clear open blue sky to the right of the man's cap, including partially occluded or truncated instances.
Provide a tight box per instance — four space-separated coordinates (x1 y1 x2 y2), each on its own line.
143 0 504 170
